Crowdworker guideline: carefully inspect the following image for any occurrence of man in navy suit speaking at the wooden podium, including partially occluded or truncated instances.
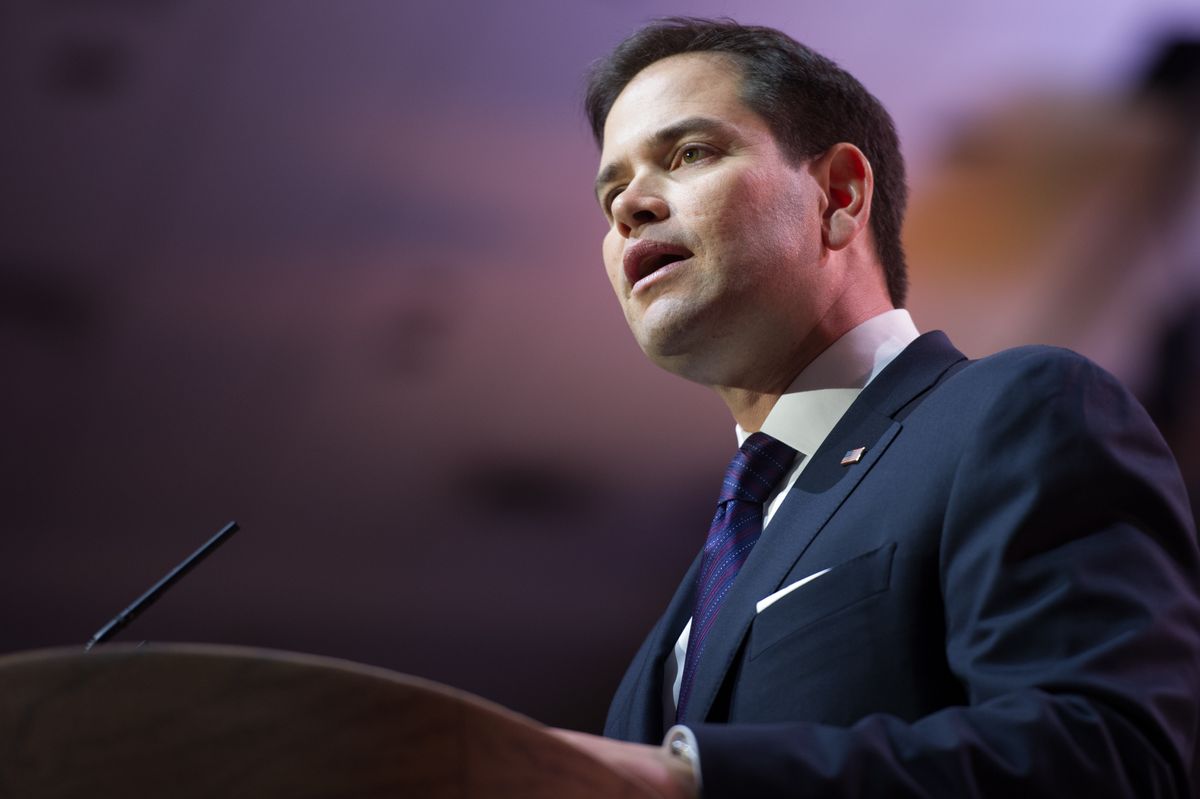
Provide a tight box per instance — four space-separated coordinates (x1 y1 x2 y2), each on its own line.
563 20 1200 798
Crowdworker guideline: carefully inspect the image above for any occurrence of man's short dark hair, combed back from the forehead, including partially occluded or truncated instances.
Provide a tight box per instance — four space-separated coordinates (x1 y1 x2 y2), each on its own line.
584 17 908 308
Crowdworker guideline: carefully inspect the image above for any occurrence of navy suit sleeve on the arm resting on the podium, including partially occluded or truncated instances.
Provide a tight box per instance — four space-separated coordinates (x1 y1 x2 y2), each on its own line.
692 350 1200 799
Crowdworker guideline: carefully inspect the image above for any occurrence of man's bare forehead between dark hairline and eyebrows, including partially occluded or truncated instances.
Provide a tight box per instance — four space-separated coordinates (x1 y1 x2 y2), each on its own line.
600 53 762 163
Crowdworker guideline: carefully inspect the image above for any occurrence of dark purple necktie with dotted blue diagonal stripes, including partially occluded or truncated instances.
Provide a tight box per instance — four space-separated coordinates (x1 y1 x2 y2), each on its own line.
676 433 796 720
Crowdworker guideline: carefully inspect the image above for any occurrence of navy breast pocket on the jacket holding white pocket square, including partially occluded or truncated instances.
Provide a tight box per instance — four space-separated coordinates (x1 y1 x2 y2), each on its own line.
749 542 896 660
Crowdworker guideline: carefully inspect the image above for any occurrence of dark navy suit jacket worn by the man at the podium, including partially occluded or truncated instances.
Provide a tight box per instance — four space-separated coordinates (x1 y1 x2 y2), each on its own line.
605 334 1200 799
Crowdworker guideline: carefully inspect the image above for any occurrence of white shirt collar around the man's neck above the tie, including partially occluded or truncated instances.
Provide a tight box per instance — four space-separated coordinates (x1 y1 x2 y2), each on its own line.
736 308 919 455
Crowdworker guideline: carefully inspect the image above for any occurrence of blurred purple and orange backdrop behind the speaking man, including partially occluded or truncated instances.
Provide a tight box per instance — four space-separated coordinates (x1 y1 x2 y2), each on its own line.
0 0 1200 729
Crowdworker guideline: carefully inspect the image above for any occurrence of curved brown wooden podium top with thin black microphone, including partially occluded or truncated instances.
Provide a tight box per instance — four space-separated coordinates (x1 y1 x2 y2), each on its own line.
0 644 654 799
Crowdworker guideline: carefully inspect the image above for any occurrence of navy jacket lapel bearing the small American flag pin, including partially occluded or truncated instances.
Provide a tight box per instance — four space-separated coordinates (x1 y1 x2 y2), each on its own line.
676 332 965 723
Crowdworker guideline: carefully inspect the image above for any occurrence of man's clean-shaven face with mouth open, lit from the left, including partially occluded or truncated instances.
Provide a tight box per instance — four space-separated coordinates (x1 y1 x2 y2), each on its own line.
596 53 830 389
